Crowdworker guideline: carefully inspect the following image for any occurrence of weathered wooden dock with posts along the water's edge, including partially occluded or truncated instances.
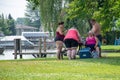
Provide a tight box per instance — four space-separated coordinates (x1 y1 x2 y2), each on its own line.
13 37 65 59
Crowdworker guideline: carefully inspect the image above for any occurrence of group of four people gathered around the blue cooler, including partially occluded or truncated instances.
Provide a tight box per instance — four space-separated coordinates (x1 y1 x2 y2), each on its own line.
55 19 102 60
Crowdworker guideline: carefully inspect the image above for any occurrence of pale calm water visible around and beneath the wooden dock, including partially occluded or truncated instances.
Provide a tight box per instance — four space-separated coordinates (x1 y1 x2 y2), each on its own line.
0 49 56 60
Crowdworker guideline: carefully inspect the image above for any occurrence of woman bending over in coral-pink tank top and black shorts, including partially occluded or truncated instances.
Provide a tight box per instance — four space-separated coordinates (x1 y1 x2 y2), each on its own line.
64 27 81 60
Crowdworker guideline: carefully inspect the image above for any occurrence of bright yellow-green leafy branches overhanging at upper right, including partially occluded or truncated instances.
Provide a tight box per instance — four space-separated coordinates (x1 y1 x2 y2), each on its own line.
67 0 120 35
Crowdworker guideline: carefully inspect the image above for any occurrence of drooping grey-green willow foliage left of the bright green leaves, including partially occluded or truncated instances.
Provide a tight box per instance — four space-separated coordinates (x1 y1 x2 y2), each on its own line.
28 0 66 31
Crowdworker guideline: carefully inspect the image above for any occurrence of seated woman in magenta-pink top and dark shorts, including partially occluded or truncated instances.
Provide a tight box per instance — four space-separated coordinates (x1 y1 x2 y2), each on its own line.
85 31 99 53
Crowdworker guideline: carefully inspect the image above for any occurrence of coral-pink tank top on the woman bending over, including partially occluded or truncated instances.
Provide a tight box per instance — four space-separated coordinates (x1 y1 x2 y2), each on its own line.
64 29 79 42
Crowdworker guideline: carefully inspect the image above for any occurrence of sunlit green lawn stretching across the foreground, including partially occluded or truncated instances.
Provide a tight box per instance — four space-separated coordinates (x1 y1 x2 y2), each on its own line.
0 53 120 80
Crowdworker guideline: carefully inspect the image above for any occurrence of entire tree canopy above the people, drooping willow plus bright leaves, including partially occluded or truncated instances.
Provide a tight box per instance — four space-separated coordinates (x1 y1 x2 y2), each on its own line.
28 0 120 34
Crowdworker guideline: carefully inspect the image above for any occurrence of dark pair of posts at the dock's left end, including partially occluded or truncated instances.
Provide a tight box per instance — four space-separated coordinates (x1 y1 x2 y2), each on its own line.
14 39 22 59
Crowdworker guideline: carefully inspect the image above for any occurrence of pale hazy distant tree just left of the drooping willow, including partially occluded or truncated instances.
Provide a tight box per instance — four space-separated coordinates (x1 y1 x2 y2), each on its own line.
25 2 41 29
